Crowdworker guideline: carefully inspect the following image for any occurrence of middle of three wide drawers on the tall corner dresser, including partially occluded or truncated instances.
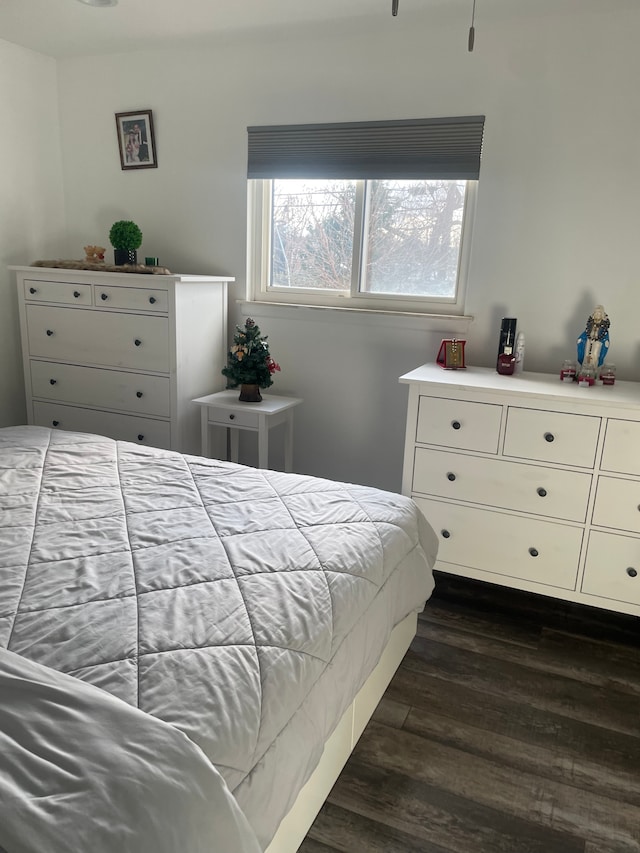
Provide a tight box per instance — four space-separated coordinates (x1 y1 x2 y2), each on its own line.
30 360 171 418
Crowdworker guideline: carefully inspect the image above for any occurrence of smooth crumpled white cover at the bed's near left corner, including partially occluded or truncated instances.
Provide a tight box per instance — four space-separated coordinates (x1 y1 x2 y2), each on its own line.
0 651 260 853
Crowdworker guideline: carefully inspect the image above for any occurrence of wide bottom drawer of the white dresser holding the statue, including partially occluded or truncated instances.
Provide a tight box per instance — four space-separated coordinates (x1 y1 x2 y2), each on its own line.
415 498 582 589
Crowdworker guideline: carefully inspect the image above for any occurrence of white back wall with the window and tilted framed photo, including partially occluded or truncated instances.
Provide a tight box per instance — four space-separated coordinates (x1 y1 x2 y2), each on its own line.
38 3 640 489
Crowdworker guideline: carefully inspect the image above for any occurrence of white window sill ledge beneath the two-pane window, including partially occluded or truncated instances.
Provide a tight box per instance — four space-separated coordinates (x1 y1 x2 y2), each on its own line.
236 299 473 337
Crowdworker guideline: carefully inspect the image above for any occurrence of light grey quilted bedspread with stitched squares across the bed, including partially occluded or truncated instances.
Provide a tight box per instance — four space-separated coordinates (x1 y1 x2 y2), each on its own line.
0 427 436 844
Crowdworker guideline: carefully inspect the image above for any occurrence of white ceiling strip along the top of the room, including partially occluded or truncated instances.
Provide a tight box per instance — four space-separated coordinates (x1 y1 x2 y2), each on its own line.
0 0 639 58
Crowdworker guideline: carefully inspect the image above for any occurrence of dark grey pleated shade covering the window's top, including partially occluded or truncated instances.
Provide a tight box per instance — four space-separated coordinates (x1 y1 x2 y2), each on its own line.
247 116 484 180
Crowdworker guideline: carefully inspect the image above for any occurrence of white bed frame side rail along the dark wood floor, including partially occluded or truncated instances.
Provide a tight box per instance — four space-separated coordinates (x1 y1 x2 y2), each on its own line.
265 613 418 853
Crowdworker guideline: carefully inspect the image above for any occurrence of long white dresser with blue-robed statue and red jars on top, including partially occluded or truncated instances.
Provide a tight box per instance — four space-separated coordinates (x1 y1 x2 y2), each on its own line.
400 364 640 615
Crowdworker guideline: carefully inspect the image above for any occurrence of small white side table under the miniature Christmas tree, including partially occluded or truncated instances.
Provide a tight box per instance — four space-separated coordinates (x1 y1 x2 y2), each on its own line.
192 388 302 471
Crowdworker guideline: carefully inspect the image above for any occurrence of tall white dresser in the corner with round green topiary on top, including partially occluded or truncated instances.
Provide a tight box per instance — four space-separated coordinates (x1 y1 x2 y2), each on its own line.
11 266 233 453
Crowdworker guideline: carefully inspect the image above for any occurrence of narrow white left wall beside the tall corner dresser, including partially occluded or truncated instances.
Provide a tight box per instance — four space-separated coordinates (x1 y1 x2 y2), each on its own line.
0 40 64 426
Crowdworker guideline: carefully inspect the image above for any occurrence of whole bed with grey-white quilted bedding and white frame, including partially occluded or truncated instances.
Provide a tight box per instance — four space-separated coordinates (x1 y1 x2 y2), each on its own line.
0 426 437 853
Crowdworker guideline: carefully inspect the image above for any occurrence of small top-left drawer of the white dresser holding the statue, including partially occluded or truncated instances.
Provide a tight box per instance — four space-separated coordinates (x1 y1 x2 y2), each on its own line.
416 395 502 453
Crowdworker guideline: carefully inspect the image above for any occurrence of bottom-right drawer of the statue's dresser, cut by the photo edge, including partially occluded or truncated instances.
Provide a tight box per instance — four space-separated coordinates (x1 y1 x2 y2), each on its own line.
581 530 640 605
